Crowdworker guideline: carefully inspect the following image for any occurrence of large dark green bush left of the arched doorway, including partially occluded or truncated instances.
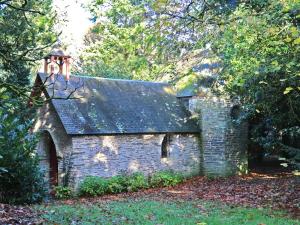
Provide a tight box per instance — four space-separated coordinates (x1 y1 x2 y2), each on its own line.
0 105 45 204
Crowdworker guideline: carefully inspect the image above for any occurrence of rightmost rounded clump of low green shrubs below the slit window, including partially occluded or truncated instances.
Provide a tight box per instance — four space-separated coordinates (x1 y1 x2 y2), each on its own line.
149 171 184 187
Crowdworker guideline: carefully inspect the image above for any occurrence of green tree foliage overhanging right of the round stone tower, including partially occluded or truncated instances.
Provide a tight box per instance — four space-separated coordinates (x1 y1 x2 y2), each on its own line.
213 0 300 167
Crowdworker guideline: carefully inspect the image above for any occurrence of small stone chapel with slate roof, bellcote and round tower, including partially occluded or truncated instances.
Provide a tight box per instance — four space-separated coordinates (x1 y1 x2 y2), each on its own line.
34 52 247 190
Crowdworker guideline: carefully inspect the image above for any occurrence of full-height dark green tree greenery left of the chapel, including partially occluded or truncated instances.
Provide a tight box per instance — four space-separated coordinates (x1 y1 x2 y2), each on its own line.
0 0 57 203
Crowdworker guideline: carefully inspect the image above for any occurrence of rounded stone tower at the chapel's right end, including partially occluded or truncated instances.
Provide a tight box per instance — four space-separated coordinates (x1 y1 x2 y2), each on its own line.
189 96 248 176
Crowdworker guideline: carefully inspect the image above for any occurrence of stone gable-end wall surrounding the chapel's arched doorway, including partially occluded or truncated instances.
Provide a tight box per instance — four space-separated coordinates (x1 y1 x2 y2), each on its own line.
33 103 72 187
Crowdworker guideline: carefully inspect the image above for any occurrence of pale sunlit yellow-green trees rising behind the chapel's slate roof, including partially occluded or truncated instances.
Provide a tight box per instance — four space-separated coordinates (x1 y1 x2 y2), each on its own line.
81 0 232 82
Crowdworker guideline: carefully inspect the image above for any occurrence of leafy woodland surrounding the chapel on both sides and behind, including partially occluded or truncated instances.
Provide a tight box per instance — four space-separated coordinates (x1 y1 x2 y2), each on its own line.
0 0 300 202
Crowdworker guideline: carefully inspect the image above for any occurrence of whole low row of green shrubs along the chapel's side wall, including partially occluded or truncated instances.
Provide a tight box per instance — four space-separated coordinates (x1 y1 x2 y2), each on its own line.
79 171 183 196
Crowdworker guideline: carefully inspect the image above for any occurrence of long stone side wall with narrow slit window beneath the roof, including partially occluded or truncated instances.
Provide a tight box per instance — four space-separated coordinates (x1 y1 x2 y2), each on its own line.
71 134 200 189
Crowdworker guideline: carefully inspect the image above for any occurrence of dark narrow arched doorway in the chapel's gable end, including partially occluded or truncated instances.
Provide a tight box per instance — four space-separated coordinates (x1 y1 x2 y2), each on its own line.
45 131 58 187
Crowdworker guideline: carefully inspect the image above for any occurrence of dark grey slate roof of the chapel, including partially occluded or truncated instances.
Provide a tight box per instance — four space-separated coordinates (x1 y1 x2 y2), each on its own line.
38 73 199 135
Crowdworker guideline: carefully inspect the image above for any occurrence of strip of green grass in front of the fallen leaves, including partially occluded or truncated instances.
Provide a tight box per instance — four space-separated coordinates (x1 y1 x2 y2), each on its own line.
37 200 300 225
